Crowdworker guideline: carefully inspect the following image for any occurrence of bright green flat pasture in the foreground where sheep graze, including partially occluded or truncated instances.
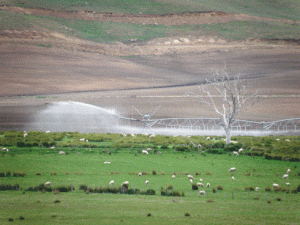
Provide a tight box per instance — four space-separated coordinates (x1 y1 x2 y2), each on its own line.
0 152 300 224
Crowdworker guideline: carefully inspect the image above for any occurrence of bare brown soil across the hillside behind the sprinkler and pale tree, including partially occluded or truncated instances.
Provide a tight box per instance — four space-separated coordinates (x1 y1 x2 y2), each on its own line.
0 8 300 130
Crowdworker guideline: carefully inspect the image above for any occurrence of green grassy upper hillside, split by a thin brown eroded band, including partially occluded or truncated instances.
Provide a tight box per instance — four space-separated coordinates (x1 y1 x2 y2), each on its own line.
0 0 300 42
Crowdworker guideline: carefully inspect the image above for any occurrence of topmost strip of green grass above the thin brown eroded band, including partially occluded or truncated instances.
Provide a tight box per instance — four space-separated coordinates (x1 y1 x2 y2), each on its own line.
0 0 300 20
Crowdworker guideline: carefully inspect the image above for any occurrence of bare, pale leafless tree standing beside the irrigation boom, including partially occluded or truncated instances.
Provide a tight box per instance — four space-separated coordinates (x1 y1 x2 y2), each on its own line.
199 70 258 144
